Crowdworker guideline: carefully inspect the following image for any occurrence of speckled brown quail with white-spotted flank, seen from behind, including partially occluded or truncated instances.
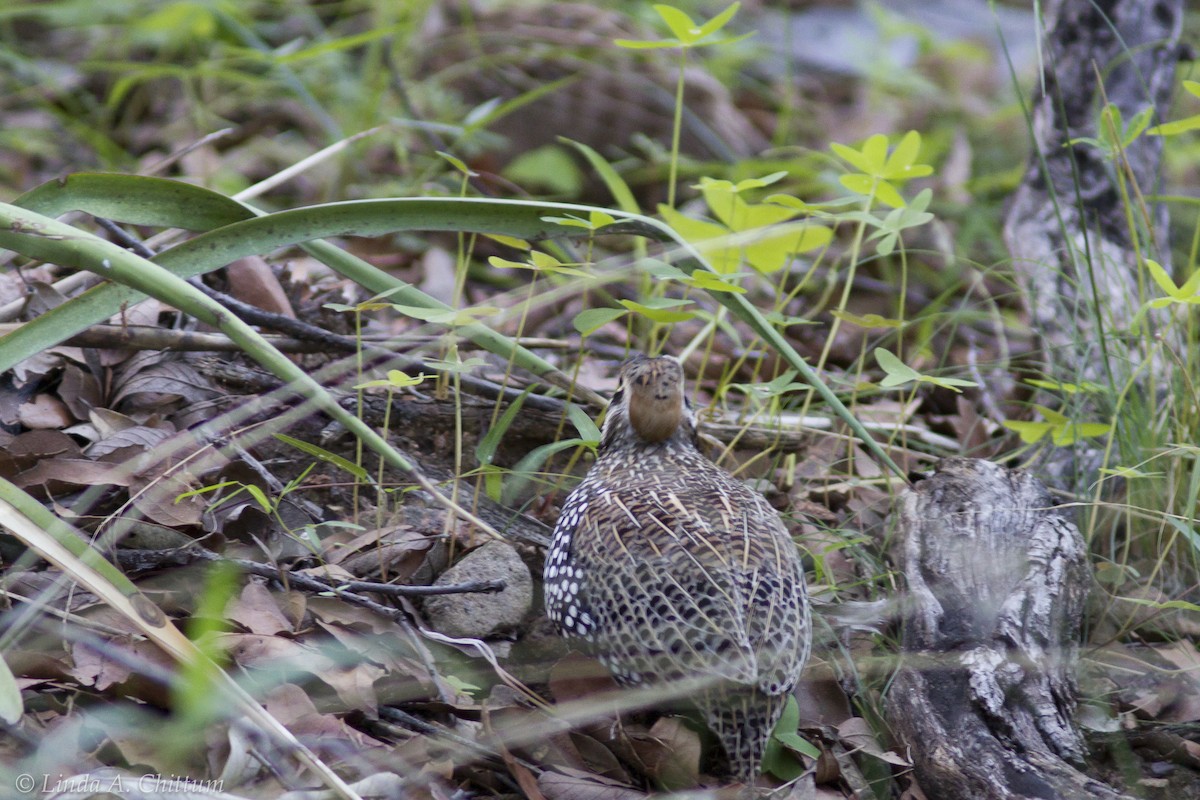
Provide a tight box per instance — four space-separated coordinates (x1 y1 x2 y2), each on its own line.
545 355 811 783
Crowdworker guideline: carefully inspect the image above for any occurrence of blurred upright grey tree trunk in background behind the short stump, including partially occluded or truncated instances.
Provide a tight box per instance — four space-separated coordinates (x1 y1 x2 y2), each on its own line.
1004 0 1183 489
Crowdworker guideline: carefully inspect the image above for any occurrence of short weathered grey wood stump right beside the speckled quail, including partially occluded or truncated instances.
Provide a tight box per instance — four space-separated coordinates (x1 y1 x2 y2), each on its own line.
888 458 1122 800
